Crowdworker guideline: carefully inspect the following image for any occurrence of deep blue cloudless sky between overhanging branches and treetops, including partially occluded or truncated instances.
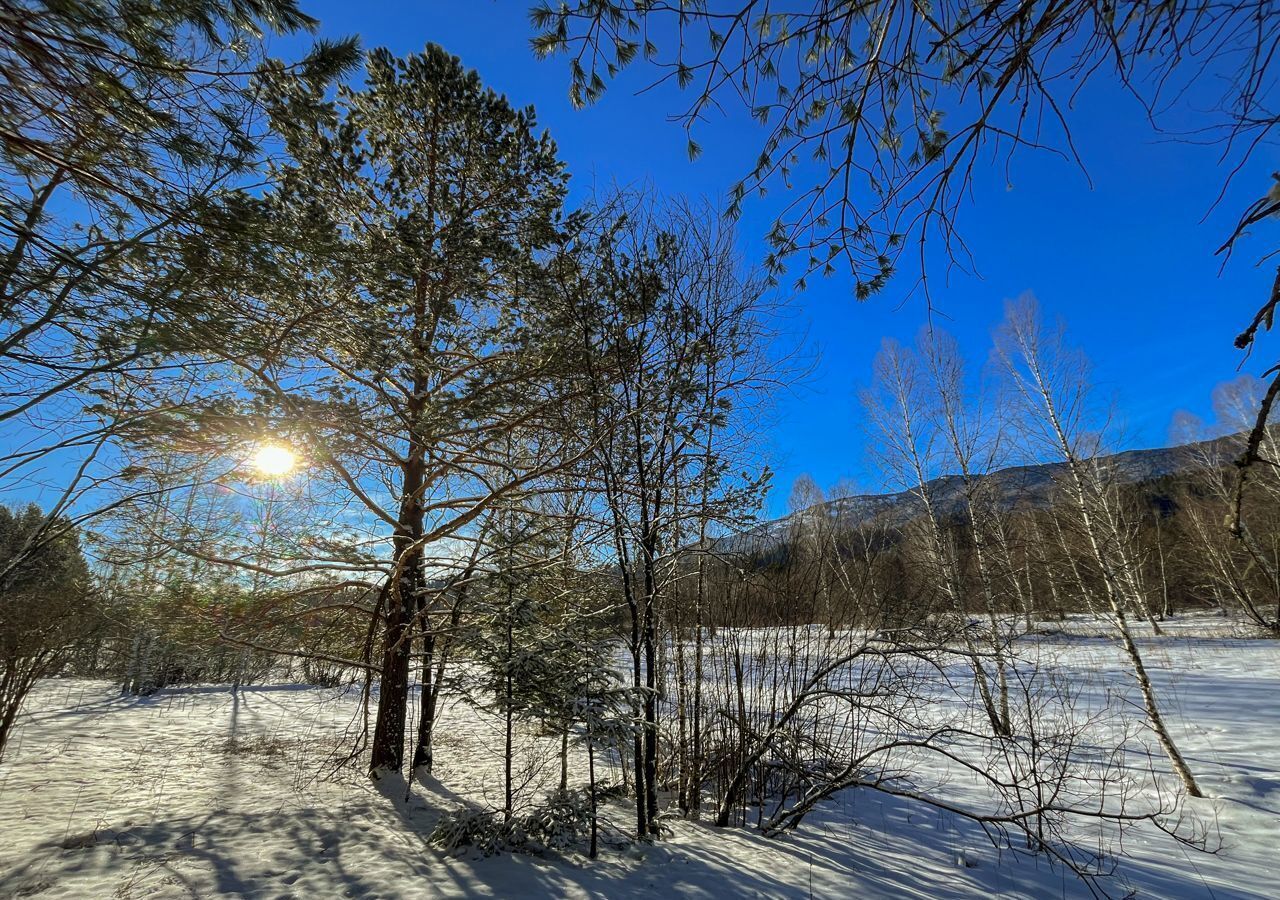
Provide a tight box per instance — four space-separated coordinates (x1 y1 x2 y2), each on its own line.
280 0 1280 513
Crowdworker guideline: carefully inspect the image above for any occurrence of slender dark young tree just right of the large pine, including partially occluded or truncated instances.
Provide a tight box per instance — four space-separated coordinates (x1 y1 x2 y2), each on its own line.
558 197 767 837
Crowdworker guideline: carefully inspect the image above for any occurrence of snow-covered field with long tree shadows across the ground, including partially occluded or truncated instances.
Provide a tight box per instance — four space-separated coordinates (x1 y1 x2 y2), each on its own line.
0 620 1280 900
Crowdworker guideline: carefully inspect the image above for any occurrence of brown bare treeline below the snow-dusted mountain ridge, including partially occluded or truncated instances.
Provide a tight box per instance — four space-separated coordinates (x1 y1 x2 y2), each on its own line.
709 376 1280 636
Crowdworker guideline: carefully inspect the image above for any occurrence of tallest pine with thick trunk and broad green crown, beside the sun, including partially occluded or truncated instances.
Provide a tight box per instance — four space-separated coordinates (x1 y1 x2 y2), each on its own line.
248 46 586 773
